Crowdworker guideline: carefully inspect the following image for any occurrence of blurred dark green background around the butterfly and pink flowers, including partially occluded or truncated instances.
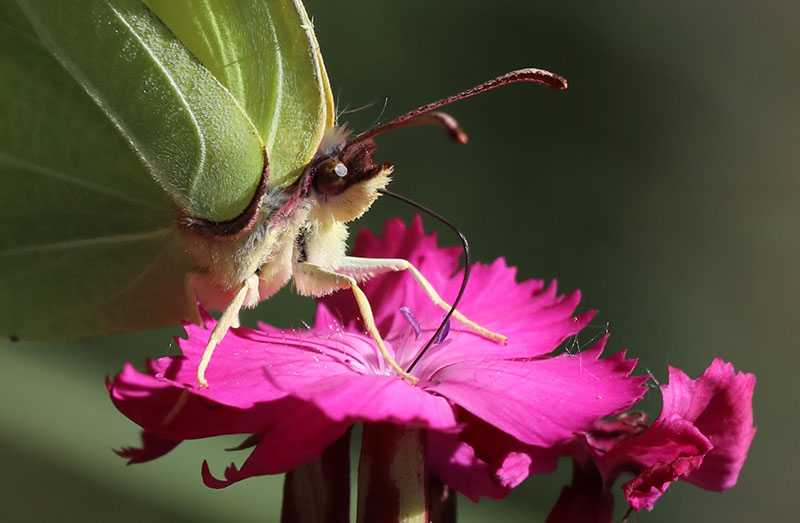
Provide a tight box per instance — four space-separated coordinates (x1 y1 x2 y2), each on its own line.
0 0 800 522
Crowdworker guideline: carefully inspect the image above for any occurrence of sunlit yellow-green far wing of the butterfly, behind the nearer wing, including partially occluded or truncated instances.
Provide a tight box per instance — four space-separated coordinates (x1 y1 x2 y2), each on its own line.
143 0 335 187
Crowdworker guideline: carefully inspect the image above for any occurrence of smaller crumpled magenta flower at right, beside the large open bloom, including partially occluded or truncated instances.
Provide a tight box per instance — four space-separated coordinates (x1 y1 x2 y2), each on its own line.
548 358 756 523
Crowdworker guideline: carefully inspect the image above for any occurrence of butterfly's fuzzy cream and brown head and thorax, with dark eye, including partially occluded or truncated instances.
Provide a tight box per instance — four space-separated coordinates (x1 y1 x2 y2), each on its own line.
181 128 392 309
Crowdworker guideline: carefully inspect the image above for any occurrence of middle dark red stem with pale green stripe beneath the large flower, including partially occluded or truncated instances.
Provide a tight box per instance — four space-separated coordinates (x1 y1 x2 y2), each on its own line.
357 423 428 523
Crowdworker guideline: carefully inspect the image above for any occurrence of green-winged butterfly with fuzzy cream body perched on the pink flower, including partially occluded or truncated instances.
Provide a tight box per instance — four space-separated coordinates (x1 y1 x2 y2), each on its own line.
0 0 567 385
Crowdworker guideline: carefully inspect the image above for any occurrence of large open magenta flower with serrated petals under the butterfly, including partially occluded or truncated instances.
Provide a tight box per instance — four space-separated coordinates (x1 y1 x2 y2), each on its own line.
109 219 645 500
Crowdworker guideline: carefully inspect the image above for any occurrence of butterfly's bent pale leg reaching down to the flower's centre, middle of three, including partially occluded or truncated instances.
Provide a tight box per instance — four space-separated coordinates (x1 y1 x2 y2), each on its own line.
294 262 418 383
